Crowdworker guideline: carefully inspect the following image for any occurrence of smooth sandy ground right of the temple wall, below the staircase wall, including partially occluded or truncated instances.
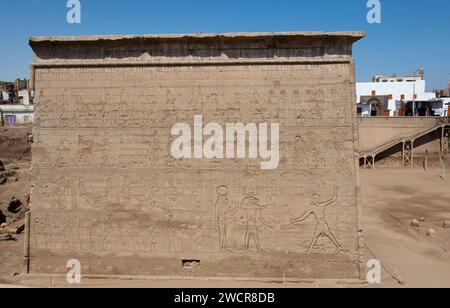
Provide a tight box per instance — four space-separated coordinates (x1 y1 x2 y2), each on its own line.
361 169 450 288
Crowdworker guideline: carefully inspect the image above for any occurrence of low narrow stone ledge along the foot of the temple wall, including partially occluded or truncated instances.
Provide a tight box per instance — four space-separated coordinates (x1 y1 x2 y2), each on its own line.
20 274 369 288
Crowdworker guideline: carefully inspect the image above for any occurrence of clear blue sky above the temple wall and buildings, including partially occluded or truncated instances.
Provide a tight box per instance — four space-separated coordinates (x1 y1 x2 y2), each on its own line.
0 0 450 89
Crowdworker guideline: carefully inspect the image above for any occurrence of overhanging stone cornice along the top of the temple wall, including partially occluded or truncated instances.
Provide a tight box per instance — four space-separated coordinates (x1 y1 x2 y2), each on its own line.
30 32 364 67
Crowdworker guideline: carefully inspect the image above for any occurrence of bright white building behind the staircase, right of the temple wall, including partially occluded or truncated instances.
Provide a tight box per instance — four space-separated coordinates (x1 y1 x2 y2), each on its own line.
356 75 436 116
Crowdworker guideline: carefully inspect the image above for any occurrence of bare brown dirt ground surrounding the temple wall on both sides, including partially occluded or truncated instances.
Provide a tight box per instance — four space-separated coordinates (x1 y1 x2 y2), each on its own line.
0 127 450 288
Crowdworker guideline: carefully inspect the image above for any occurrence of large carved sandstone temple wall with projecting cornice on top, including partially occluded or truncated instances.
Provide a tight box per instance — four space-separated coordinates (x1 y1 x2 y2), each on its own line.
25 32 364 279
